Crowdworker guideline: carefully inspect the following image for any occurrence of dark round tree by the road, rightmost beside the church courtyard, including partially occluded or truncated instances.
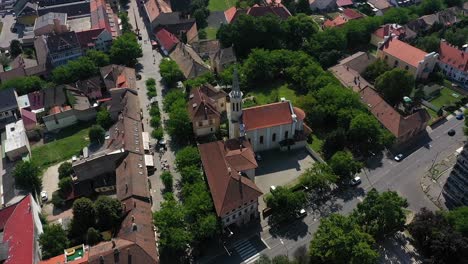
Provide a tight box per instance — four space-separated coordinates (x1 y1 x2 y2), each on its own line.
328 151 363 181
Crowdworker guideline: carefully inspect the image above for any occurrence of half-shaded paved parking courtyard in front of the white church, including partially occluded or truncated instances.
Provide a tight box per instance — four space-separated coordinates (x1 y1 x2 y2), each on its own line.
255 148 315 211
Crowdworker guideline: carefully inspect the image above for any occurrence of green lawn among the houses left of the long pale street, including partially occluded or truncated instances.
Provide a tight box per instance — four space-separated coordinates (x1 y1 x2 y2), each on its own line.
31 124 90 169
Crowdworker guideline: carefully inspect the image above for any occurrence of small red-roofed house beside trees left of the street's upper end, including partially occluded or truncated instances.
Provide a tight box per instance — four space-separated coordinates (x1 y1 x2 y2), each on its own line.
76 28 112 53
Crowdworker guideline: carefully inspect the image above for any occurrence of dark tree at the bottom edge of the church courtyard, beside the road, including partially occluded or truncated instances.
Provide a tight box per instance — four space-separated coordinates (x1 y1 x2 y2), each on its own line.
266 186 307 222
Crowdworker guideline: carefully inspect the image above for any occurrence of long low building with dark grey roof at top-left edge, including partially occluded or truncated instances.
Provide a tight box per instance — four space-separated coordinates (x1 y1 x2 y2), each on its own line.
37 0 90 19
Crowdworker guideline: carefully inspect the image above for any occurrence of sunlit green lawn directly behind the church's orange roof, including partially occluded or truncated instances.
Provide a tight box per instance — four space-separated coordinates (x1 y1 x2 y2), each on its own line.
244 81 297 105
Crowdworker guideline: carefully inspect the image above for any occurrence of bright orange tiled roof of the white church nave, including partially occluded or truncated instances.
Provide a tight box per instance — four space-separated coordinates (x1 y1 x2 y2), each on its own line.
242 101 293 131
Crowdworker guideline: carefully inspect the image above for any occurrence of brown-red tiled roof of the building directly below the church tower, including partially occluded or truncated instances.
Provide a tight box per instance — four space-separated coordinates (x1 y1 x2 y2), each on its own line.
198 141 262 216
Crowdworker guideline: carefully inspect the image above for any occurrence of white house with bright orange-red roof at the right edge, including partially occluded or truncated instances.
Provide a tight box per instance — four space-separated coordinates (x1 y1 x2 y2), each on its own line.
439 39 468 88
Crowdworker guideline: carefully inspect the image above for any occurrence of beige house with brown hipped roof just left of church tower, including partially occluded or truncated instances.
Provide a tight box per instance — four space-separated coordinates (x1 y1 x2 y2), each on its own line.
187 84 227 137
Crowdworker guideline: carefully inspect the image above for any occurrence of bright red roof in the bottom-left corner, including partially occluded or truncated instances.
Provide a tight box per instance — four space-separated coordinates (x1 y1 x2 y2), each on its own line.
3 194 35 264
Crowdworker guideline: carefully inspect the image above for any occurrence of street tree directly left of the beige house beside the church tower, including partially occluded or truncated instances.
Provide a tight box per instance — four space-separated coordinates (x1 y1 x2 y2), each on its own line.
167 108 193 143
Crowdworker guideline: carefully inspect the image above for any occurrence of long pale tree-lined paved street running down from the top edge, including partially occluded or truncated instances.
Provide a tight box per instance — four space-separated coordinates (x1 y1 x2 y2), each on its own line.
128 1 180 211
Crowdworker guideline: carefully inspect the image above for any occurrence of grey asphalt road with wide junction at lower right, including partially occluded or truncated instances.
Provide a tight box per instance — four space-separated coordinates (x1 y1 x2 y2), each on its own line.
207 114 465 263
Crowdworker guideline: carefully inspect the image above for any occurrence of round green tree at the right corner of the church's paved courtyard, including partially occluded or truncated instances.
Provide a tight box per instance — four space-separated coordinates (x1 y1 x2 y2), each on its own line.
300 163 338 193
